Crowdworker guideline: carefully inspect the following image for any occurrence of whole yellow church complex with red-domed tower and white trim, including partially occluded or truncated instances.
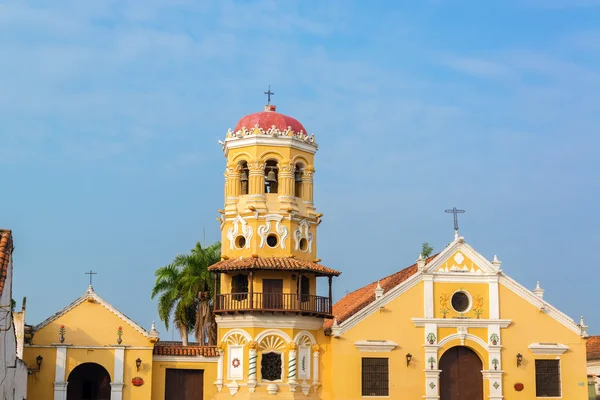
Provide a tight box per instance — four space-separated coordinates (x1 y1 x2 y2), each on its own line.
25 104 588 400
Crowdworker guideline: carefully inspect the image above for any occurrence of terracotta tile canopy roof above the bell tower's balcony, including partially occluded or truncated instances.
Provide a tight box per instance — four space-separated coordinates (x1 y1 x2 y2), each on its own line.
208 257 341 276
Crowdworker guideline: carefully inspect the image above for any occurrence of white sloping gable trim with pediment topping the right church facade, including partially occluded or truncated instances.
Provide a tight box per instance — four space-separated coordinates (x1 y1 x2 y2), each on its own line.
332 236 587 336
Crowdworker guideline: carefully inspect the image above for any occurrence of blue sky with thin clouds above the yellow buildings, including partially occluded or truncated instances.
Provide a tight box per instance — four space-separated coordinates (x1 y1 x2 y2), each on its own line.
0 0 600 339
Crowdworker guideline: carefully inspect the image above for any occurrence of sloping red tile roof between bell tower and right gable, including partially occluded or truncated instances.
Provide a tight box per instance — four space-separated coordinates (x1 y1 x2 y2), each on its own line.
323 254 437 329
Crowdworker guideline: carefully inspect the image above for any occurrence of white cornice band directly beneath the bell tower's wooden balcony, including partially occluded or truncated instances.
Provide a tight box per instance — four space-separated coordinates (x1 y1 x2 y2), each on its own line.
215 314 323 331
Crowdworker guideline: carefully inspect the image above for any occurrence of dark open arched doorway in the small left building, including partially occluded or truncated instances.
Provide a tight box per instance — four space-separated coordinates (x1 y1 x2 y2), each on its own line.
67 363 110 400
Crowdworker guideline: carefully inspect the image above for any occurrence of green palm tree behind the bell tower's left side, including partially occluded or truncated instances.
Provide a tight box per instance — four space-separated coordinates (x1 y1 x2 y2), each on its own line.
152 242 221 346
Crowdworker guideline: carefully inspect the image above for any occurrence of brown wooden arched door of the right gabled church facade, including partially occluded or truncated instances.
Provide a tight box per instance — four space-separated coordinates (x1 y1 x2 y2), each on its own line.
439 346 483 400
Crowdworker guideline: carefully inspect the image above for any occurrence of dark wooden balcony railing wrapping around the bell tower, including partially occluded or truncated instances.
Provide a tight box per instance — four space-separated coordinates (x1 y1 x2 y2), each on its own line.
215 292 332 318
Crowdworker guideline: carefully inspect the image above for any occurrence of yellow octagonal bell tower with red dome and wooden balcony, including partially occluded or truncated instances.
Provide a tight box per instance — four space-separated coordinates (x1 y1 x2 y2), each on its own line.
209 101 340 398
